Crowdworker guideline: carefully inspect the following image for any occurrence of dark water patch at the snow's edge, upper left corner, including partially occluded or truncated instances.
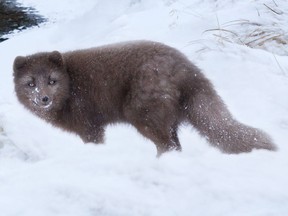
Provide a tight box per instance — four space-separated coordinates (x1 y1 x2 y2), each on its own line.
0 0 45 42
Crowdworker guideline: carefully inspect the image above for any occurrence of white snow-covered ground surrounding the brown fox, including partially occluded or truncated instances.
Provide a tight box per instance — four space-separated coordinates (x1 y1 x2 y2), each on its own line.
0 0 288 216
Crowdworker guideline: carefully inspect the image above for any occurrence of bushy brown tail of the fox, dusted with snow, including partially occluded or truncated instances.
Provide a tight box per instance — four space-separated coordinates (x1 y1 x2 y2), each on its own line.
186 78 276 153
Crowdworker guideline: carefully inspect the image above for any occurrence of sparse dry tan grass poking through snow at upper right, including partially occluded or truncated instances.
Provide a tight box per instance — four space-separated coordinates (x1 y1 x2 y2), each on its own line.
203 1 288 55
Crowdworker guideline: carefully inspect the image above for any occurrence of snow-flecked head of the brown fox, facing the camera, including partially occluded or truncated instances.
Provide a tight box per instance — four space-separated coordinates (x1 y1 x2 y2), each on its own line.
13 51 69 114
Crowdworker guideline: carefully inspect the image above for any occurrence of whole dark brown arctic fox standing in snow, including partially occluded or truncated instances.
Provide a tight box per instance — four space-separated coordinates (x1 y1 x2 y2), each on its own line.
14 41 276 155
